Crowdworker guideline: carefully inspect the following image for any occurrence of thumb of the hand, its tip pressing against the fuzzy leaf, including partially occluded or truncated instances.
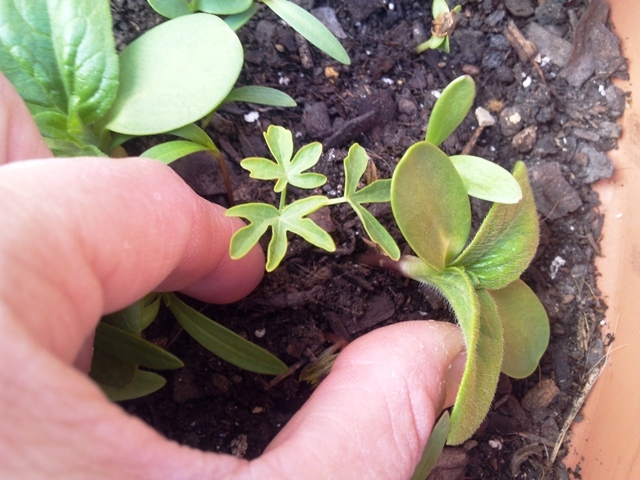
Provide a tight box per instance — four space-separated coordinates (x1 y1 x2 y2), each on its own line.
241 321 465 480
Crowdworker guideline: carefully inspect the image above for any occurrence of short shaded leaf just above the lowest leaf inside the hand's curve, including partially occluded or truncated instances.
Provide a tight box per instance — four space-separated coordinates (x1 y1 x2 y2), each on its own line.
94 322 184 370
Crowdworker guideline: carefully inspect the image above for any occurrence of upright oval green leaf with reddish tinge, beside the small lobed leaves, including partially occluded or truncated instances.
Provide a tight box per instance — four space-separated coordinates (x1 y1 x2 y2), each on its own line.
391 142 471 271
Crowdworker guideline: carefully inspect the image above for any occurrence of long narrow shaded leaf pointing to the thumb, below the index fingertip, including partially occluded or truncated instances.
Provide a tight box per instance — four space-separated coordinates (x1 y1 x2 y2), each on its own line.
163 293 288 375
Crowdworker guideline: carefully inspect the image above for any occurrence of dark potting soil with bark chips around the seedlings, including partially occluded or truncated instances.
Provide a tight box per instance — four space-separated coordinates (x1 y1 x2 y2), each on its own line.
111 0 626 480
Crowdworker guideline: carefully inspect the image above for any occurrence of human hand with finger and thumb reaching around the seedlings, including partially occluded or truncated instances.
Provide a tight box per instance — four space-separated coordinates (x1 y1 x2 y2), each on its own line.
0 75 464 480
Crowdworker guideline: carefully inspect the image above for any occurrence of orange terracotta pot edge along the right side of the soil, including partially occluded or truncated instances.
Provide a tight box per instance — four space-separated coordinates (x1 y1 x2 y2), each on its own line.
565 0 640 480
